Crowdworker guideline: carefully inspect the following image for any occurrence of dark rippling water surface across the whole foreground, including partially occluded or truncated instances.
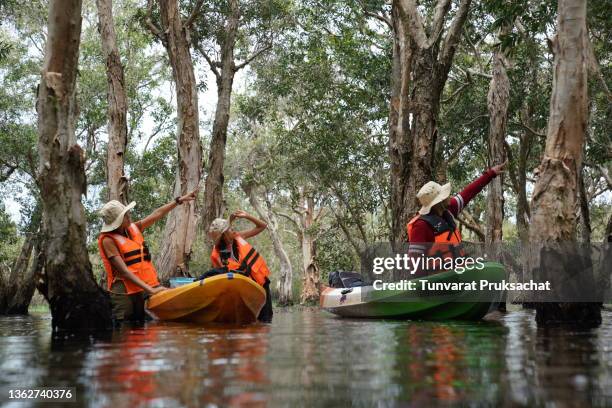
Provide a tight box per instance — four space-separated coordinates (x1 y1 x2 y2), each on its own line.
0 310 612 407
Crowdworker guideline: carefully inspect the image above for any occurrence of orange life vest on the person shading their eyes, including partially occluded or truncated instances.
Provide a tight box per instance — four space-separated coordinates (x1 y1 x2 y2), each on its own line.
210 235 270 286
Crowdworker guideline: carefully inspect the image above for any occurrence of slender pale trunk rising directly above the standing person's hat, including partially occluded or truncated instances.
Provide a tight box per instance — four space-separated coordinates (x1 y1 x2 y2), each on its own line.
96 0 128 204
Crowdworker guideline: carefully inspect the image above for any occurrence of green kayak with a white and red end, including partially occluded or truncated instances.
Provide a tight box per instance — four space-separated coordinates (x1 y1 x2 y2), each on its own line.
320 262 506 320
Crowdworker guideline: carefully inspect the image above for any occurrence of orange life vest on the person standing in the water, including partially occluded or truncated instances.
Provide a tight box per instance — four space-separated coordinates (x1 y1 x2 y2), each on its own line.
98 223 159 295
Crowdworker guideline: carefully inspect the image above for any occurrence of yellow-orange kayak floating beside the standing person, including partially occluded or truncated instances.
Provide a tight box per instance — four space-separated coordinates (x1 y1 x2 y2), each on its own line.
146 272 266 324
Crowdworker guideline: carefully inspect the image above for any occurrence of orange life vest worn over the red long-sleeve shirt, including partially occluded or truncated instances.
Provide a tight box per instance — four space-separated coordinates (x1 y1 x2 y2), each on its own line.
406 212 465 259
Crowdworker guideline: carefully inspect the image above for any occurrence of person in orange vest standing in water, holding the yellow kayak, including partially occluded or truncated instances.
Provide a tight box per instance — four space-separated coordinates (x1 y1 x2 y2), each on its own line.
98 190 197 321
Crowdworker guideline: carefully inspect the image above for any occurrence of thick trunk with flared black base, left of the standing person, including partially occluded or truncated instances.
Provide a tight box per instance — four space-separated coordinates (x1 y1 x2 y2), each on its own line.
37 0 111 329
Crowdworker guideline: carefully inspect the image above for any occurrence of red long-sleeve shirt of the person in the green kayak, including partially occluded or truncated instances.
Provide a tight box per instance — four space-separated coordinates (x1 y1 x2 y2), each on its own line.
409 169 496 244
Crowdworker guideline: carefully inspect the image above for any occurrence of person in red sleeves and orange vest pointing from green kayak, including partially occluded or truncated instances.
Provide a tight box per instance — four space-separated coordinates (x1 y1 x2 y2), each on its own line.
406 161 508 275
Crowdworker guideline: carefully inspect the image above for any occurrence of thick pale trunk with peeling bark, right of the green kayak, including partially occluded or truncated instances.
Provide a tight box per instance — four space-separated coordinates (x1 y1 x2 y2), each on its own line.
530 0 601 326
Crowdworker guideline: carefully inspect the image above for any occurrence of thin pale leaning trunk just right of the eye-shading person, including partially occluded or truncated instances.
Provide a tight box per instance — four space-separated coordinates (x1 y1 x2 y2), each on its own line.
242 185 293 306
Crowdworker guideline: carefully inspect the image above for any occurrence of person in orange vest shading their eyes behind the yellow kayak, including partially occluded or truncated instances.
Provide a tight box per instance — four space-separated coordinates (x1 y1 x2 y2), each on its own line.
200 210 273 322
